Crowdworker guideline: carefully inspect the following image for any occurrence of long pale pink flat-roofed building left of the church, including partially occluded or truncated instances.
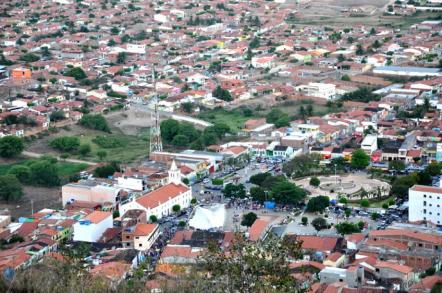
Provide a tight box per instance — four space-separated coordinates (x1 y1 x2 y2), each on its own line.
61 180 120 206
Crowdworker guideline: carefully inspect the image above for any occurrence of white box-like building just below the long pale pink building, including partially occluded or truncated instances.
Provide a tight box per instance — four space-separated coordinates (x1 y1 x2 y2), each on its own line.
73 211 114 242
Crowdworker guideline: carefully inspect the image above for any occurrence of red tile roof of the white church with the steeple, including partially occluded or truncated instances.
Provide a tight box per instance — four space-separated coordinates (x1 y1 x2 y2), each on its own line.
137 183 189 209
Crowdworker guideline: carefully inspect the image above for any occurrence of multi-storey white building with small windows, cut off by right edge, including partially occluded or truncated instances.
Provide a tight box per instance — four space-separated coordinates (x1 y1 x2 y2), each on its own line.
408 185 442 226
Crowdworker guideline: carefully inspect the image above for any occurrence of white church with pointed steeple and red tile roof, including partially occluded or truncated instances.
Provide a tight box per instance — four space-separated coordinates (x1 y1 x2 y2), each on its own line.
119 161 192 219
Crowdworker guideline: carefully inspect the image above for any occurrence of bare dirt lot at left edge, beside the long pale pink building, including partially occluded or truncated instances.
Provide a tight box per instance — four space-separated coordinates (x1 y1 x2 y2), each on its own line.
0 186 62 218
